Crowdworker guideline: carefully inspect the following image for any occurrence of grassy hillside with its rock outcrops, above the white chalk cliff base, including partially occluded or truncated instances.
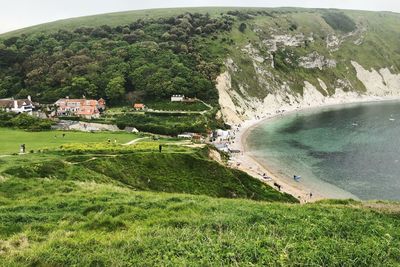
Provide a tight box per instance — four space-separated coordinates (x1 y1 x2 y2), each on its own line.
226 10 400 99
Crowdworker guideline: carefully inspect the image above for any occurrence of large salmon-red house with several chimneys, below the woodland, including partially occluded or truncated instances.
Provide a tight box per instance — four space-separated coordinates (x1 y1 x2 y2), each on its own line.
54 97 106 119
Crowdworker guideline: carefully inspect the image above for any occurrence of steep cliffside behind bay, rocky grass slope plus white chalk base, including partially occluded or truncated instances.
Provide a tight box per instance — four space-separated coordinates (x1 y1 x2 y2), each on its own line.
217 9 400 125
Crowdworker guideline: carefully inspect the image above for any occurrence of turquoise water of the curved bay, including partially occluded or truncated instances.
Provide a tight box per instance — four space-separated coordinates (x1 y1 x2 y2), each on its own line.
247 102 400 200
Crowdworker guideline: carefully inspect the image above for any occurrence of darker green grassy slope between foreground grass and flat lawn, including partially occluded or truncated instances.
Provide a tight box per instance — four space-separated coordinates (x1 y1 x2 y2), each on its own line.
0 134 298 202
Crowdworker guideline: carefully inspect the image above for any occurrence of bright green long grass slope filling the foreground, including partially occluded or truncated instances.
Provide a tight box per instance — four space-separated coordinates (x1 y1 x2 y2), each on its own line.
0 178 400 266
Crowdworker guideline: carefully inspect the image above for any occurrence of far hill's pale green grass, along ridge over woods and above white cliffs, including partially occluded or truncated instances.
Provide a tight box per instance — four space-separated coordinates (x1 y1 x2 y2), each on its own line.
0 7 400 98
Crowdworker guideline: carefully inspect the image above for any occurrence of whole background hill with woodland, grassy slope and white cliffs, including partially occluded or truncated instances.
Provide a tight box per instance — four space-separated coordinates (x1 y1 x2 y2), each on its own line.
0 8 400 117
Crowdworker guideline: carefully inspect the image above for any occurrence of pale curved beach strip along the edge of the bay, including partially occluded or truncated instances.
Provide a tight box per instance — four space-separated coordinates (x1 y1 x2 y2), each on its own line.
225 96 400 203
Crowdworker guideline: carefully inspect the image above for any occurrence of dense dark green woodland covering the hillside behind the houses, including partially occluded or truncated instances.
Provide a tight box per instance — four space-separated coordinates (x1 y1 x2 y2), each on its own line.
0 13 233 105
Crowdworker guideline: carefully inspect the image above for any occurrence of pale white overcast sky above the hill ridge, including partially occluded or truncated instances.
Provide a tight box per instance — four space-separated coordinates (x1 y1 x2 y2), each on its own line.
0 0 400 33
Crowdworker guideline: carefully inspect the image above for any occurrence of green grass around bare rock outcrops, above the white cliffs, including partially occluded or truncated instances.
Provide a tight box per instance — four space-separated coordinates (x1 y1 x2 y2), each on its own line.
223 9 400 98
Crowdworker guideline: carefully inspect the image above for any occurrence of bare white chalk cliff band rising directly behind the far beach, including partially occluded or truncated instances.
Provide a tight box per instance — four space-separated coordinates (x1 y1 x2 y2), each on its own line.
217 59 400 125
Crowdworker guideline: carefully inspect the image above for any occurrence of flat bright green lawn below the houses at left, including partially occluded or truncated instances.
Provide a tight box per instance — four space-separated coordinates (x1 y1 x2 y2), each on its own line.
0 128 138 155
